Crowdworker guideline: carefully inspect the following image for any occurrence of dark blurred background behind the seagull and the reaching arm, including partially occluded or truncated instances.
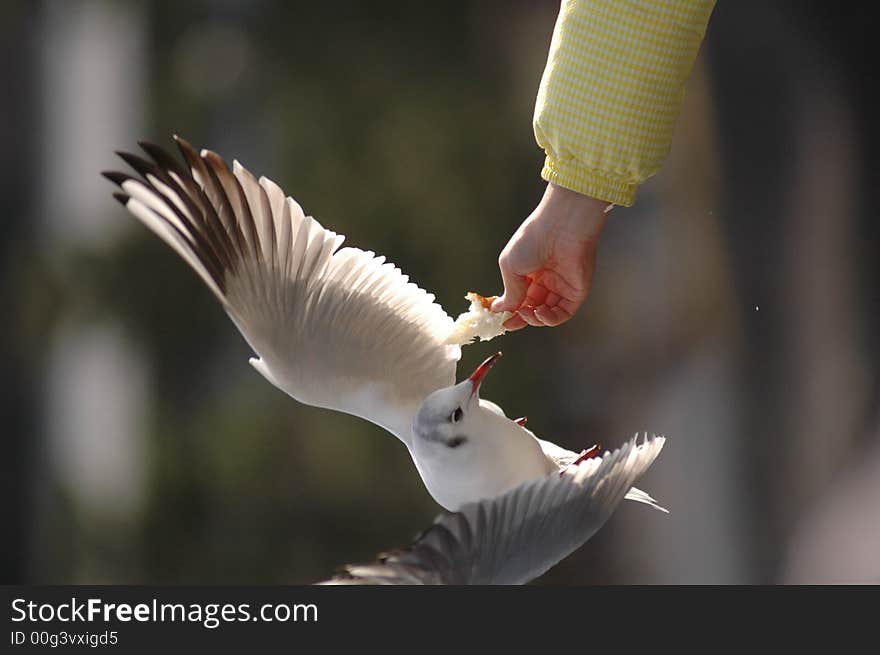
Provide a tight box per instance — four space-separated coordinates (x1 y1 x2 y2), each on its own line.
0 0 880 584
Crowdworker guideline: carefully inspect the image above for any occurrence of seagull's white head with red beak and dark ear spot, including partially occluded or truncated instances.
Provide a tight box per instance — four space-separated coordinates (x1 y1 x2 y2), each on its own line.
413 352 501 450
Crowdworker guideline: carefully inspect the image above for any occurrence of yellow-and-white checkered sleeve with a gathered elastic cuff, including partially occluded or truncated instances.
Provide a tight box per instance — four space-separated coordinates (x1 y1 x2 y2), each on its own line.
534 0 715 206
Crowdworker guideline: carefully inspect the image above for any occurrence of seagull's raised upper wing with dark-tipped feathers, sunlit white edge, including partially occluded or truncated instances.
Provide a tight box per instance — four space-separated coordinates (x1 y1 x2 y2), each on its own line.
104 137 461 444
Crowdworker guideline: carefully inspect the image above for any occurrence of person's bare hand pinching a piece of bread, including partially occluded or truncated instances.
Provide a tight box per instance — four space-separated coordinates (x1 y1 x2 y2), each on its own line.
492 184 609 330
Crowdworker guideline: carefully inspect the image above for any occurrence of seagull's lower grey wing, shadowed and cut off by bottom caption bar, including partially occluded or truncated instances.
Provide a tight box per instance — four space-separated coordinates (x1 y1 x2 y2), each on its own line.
325 437 665 584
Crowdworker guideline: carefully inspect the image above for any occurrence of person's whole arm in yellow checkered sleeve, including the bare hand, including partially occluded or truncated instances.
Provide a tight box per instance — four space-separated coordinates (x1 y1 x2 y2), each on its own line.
493 0 714 329
